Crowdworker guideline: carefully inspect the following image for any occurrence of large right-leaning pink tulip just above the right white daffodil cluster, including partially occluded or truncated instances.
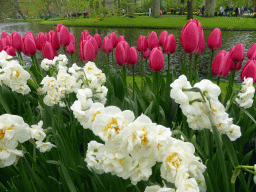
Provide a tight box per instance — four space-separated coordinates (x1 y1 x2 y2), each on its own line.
211 50 230 77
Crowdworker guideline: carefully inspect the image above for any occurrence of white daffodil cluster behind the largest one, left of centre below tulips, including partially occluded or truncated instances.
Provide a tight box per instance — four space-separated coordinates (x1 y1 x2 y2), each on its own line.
38 55 107 107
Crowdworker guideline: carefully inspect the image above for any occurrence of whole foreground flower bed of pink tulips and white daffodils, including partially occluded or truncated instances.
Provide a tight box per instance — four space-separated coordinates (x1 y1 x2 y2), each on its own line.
0 19 256 192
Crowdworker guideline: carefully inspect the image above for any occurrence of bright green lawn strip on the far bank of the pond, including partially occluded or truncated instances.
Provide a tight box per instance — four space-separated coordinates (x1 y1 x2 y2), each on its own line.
36 15 256 30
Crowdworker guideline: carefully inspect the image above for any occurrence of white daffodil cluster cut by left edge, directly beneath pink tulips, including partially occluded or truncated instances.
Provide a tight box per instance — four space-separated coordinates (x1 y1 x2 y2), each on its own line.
0 51 30 95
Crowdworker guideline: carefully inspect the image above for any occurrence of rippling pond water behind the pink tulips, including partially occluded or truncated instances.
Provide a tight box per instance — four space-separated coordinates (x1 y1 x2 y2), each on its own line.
0 21 256 82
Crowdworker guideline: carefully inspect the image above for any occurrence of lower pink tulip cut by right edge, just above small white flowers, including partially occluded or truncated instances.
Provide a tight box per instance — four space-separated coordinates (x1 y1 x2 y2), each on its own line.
240 60 256 83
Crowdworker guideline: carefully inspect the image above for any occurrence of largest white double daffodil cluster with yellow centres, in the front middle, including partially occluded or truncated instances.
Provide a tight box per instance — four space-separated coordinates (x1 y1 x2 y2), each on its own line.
85 103 206 191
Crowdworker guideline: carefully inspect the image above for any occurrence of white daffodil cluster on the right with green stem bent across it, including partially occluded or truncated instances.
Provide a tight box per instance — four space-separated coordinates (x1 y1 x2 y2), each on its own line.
170 75 241 141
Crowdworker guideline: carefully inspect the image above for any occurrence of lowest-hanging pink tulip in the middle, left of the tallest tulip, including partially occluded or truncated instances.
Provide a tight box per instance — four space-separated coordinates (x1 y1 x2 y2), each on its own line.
149 48 164 72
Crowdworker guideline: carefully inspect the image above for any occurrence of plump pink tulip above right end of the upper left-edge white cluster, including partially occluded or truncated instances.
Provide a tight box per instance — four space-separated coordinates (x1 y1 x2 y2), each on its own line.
22 35 36 56
